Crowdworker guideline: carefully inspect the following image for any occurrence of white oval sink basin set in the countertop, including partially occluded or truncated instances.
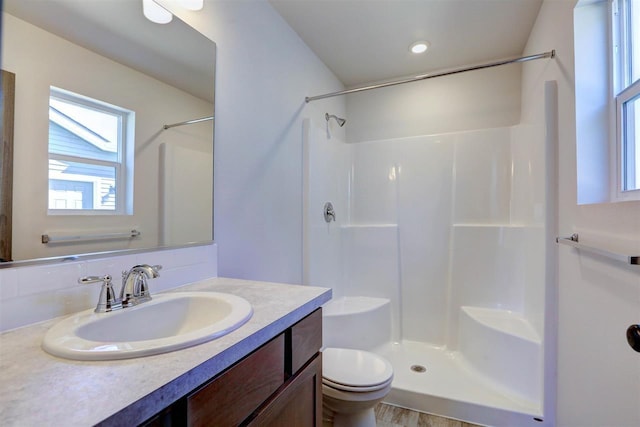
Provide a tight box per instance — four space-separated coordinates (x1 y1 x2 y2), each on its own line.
42 292 253 360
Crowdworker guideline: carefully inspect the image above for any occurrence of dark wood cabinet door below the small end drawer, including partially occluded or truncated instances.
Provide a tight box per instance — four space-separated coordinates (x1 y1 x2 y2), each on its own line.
247 353 322 427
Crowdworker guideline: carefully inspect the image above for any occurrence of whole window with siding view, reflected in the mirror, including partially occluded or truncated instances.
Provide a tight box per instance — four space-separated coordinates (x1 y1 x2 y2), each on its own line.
48 87 134 215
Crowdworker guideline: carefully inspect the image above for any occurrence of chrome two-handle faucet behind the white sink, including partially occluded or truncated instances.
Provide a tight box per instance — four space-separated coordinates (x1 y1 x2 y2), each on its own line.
78 264 162 313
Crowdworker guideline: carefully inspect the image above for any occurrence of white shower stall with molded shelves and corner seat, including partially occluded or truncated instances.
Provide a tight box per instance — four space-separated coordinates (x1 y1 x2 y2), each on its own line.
303 75 557 426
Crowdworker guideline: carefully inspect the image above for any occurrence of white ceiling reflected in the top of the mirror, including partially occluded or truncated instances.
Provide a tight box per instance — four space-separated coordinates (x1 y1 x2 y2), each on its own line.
2 0 216 102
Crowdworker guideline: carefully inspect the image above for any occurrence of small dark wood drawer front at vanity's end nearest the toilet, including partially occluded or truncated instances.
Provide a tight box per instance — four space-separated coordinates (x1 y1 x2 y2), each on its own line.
287 308 322 375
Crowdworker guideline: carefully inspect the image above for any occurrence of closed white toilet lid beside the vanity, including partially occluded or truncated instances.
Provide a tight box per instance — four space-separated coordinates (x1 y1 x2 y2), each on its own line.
322 348 393 388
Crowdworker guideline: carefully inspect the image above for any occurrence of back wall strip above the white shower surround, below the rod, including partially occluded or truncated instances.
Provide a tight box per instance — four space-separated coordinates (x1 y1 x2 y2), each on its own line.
347 64 521 143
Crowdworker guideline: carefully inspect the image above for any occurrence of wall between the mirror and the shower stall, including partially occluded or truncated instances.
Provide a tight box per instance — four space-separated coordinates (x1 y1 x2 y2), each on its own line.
160 0 345 283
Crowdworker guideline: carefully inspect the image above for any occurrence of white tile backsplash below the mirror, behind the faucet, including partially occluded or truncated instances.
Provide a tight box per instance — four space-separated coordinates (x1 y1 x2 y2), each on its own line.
0 244 218 332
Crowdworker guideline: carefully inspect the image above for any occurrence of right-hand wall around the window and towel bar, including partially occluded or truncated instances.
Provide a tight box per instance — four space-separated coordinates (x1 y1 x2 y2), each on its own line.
522 0 640 427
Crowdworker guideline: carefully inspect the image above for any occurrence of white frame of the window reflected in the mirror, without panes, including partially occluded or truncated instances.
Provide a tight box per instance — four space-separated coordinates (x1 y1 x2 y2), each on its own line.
47 86 135 216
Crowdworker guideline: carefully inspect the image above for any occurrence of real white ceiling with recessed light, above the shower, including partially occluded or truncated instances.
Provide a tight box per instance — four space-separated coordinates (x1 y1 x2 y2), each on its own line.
269 0 542 87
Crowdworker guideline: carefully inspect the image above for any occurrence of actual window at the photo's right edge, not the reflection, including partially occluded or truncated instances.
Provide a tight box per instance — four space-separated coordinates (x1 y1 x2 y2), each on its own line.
613 0 640 199
